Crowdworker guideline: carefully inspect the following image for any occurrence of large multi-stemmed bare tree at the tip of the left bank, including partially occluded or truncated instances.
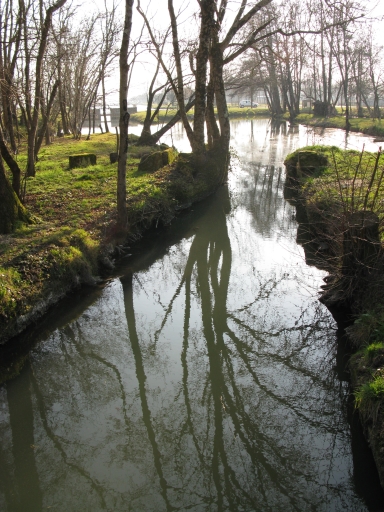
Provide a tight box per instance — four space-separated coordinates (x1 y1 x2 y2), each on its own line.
138 0 272 167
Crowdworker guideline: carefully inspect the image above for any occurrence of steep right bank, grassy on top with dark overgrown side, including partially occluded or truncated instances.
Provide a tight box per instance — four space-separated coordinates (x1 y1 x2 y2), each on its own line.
285 147 384 488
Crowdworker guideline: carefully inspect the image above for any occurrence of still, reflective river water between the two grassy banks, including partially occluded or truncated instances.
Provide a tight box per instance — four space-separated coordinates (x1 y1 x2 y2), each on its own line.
0 120 384 512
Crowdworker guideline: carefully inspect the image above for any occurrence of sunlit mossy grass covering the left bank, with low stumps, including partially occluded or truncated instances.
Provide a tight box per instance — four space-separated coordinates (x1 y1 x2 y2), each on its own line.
0 134 212 348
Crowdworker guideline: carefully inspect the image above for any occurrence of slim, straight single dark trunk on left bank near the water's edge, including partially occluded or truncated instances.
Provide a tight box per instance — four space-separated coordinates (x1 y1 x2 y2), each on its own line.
117 0 134 231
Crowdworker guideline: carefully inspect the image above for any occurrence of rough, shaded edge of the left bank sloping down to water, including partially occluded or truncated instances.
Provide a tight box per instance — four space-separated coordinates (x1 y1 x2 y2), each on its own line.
0 148 228 348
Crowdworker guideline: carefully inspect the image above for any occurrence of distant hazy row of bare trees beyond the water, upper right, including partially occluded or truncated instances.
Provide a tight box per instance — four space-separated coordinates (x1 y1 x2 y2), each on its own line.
226 1 384 127
